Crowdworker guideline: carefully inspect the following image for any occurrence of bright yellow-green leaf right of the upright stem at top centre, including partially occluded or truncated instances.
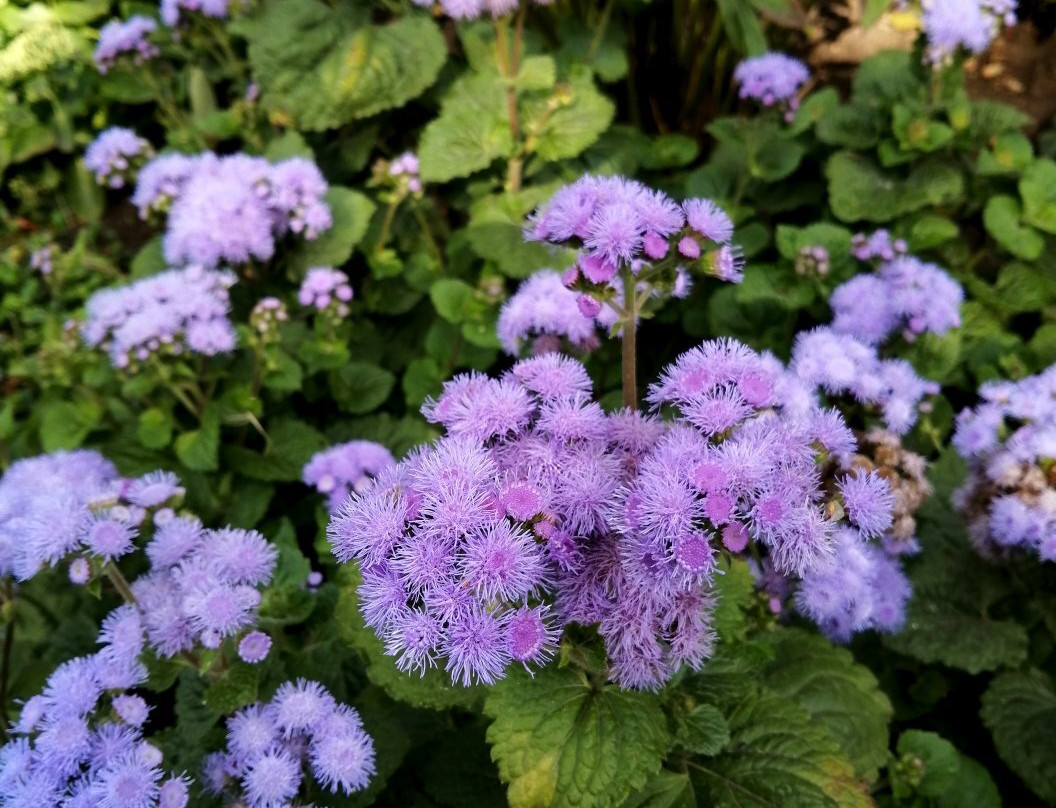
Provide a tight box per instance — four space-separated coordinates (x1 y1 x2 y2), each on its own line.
532 65 616 161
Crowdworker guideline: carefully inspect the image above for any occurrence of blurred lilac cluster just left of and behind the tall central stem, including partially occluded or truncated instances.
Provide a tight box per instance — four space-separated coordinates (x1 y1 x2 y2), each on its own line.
496 269 615 356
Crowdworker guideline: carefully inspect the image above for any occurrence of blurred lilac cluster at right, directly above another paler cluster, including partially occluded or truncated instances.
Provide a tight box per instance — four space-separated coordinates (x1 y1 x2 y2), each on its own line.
829 230 964 345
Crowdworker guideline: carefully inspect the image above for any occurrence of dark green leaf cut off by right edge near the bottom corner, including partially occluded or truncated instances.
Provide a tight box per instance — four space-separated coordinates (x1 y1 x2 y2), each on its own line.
981 669 1056 803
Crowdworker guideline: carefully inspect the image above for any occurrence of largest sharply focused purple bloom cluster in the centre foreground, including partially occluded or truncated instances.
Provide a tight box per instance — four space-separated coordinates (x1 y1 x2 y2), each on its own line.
329 341 908 688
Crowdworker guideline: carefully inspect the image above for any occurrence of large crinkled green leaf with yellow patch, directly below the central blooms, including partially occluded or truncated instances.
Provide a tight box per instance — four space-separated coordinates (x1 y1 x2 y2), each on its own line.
484 665 671 808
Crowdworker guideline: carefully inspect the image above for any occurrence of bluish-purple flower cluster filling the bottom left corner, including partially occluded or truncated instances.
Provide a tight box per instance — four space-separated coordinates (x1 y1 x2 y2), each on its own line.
0 605 189 808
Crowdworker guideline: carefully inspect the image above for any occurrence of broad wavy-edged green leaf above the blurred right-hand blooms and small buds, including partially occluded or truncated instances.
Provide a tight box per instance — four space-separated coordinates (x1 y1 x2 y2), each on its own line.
825 151 964 222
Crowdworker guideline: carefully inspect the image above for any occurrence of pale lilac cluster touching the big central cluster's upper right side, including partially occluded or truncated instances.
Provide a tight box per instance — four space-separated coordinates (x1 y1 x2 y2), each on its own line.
790 326 939 435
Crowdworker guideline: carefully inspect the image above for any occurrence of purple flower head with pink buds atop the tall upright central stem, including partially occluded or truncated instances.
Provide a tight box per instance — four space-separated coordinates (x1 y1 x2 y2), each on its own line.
525 174 744 319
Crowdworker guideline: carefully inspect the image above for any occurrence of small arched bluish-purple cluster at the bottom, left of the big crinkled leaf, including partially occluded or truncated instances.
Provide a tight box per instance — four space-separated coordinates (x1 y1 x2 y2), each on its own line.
205 679 374 808
